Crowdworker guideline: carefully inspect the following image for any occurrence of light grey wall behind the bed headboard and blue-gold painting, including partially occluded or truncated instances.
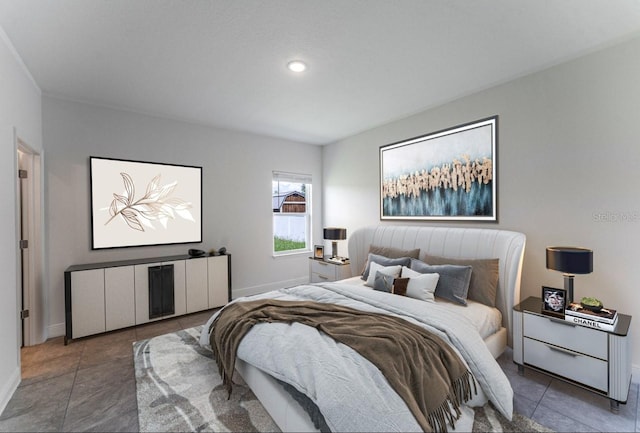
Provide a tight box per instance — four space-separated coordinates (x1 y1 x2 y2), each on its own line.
323 39 640 366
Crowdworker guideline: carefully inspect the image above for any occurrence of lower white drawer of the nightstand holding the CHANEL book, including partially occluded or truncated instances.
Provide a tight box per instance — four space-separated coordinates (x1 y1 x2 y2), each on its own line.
524 336 609 392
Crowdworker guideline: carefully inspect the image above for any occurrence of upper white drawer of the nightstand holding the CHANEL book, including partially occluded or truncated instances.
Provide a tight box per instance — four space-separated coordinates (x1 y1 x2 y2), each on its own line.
524 314 608 360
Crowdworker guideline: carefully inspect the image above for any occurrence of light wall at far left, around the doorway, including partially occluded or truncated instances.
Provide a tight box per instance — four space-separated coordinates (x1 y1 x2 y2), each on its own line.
0 29 42 412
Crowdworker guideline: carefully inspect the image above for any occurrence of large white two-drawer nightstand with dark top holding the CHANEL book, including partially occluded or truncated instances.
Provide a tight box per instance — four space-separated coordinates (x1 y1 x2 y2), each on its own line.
513 297 631 412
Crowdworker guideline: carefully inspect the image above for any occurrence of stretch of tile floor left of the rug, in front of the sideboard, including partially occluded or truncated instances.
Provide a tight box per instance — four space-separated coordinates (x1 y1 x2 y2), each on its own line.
0 310 213 432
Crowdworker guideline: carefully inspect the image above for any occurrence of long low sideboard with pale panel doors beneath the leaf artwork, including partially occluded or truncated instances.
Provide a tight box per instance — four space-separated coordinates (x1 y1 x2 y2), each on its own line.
64 254 231 344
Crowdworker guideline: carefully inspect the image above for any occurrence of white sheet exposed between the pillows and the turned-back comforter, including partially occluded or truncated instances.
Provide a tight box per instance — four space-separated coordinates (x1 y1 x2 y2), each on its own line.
339 276 502 339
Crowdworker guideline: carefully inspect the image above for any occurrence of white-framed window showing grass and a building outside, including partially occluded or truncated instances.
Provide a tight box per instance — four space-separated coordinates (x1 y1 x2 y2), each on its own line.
271 171 311 255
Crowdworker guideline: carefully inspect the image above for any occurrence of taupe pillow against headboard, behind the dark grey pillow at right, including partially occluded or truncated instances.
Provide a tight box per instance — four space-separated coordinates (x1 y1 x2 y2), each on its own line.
422 254 500 307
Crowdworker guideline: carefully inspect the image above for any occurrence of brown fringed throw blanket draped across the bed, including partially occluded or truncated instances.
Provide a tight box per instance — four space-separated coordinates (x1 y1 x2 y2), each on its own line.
210 299 477 432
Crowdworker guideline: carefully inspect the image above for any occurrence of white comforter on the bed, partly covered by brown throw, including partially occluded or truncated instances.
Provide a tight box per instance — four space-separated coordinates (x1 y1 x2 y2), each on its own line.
200 283 513 431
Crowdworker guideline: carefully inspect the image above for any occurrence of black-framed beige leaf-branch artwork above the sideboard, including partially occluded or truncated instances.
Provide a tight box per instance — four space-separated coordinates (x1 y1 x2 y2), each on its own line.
89 156 203 250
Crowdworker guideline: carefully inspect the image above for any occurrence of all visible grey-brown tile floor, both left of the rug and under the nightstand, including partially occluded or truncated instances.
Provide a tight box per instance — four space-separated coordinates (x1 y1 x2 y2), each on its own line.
0 311 640 432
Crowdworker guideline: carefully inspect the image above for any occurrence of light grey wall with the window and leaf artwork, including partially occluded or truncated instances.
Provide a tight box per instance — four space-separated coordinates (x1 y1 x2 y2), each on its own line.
43 97 322 335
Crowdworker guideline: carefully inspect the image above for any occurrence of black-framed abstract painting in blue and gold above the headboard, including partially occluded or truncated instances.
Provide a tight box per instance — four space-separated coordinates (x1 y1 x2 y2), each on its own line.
380 115 498 222
